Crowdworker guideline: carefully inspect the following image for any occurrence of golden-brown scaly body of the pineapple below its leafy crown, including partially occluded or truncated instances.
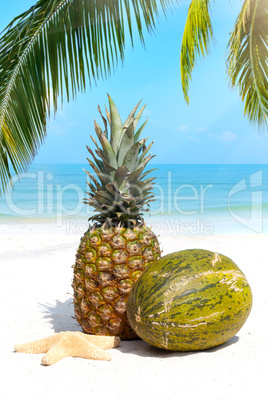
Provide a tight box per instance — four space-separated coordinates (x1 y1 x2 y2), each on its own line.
73 226 160 339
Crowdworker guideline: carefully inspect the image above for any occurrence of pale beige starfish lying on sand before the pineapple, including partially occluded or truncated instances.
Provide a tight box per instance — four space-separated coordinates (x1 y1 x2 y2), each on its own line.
15 331 120 366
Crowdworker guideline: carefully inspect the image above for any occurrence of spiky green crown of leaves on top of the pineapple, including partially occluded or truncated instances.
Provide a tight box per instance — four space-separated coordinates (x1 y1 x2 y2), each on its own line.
84 95 155 226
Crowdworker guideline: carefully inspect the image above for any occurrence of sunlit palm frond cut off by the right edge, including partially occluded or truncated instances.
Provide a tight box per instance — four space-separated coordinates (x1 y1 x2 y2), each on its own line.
227 0 268 128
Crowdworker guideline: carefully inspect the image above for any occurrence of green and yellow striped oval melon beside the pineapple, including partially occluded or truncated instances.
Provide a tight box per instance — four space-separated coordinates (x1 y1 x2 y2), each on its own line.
127 249 252 351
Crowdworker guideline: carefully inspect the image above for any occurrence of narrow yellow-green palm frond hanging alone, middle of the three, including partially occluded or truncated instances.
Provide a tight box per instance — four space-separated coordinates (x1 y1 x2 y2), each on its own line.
181 0 213 104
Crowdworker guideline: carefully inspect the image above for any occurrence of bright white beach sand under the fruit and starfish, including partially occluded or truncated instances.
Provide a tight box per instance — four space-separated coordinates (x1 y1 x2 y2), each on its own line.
0 224 268 402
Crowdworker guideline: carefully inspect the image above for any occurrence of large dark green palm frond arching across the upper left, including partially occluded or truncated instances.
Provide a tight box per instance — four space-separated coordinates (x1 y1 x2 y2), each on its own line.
0 0 172 195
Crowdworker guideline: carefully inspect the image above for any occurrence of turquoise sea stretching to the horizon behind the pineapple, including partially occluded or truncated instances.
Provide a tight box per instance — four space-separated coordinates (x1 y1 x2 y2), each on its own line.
0 164 268 235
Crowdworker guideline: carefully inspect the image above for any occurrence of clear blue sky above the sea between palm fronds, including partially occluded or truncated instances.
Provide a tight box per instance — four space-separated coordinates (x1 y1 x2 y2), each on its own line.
0 0 268 164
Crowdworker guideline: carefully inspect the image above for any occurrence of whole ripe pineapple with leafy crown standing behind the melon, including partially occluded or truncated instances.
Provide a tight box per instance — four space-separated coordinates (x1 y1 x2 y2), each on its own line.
73 95 160 339
